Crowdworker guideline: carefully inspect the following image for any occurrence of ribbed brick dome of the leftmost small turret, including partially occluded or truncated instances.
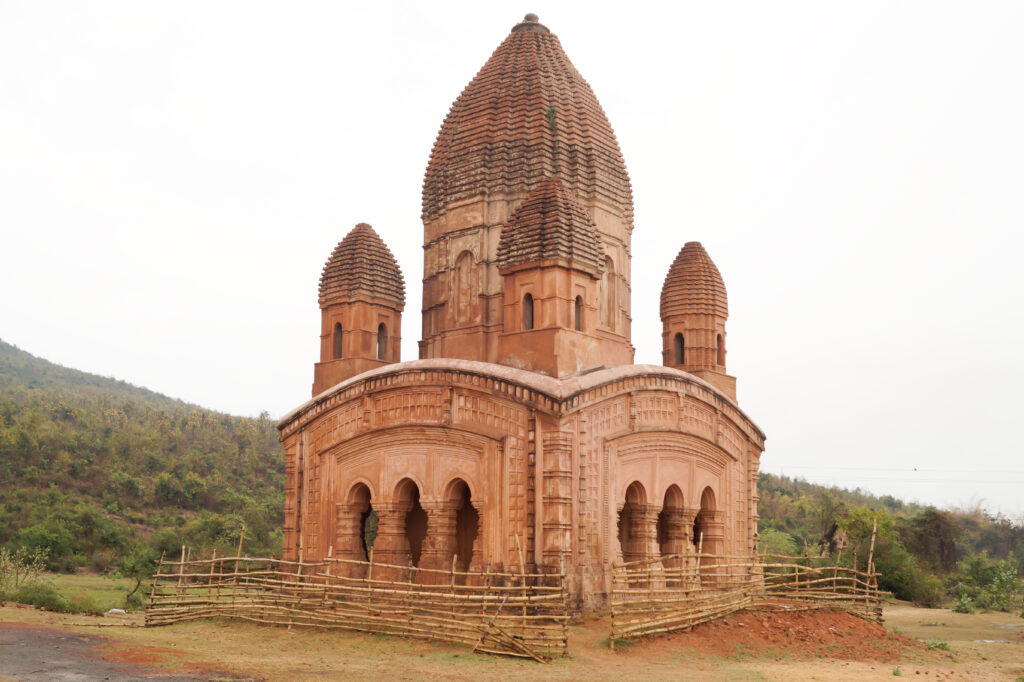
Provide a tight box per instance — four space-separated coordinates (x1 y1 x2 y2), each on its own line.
319 222 406 310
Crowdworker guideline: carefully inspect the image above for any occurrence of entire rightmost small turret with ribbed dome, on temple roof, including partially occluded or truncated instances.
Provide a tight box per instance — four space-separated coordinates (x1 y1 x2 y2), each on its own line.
662 242 736 399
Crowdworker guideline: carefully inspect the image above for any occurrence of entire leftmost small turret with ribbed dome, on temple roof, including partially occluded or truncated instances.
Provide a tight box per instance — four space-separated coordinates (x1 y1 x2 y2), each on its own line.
313 222 406 395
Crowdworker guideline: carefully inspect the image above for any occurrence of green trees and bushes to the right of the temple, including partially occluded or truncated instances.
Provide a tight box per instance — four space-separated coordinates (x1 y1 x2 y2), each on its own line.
758 473 1024 615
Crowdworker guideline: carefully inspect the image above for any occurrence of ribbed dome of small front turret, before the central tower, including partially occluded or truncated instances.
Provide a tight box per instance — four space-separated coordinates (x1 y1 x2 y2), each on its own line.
498 176 604 274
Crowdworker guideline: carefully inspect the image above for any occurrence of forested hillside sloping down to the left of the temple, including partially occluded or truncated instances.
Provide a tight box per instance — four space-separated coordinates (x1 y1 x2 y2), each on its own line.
0 341 285 570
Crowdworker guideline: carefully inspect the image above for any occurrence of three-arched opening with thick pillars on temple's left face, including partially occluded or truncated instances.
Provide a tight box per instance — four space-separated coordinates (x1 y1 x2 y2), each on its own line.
336 478 480 582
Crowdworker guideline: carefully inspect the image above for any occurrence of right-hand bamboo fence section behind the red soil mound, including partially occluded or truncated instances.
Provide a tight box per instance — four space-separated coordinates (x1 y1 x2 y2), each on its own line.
608 540 882 648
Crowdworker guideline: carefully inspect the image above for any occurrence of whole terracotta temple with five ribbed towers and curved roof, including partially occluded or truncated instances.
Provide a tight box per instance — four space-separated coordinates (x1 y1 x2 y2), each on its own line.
279 14 764 609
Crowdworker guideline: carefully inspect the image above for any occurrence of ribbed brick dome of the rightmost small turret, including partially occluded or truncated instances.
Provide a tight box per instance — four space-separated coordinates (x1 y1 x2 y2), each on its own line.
662 242 729 319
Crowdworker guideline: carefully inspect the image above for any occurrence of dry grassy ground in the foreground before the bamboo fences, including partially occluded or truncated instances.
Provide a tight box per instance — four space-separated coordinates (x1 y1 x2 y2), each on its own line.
0 598 1024 682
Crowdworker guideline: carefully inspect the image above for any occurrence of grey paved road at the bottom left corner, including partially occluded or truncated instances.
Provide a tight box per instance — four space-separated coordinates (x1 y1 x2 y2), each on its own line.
0 623 197 682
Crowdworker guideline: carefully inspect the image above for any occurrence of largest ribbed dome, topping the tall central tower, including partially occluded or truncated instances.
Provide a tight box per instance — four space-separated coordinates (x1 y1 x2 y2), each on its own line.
423 15 633 224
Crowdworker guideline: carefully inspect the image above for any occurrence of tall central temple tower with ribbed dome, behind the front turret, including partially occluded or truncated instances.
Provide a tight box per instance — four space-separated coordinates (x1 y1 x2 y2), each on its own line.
420 14 633 374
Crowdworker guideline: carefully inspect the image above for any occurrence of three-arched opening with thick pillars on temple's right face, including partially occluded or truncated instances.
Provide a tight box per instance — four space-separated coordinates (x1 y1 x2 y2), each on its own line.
617 481 724 563
